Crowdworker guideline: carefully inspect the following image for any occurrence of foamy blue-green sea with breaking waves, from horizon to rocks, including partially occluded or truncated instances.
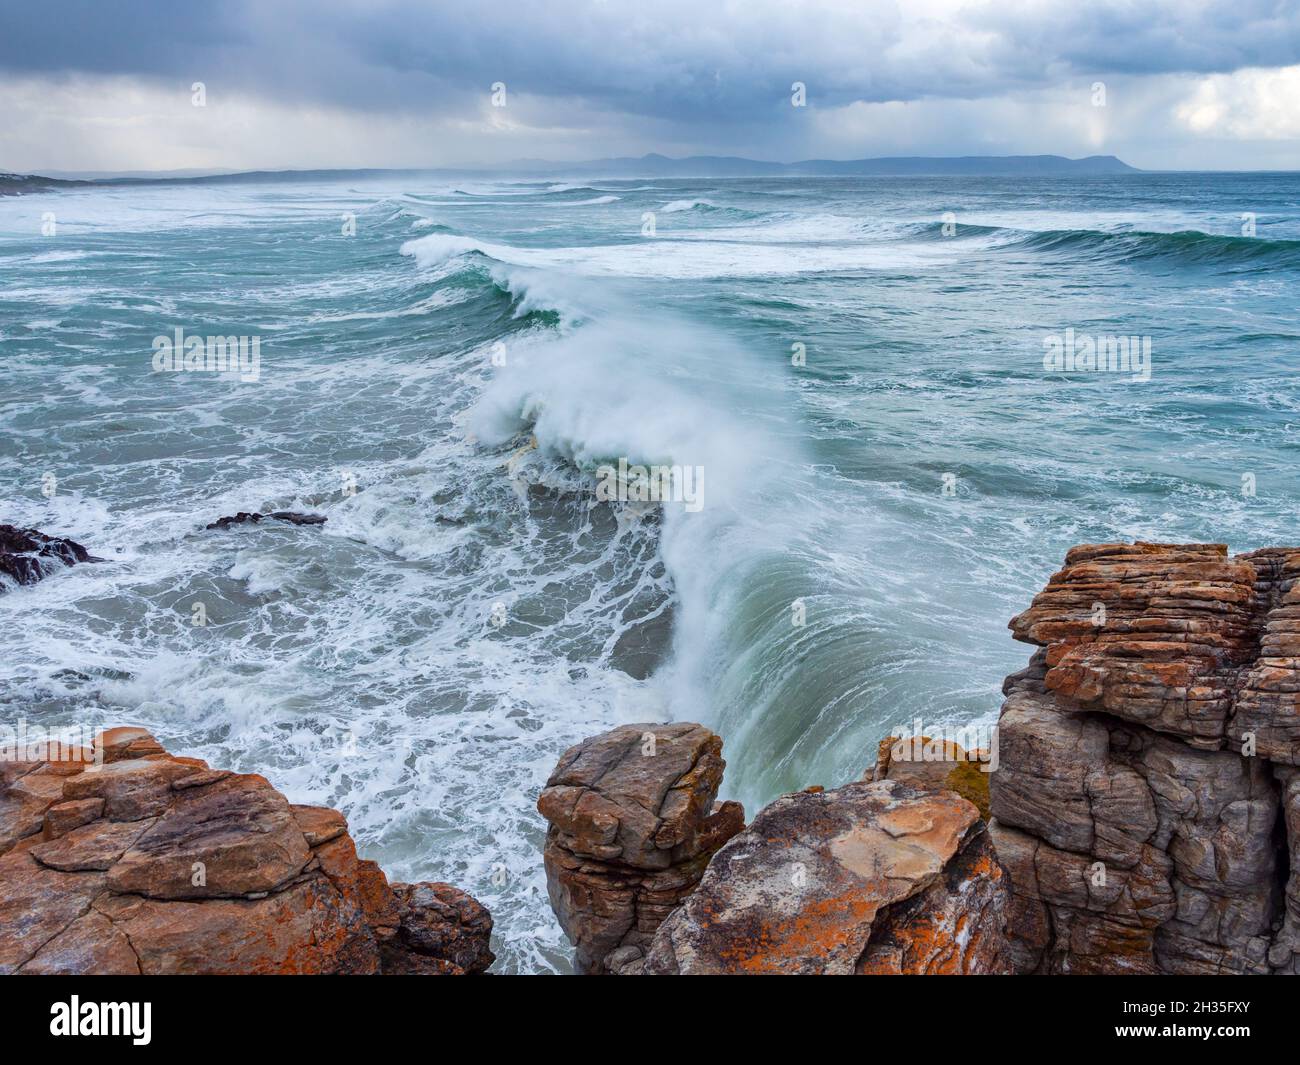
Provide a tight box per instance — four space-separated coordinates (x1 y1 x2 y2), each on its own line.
0 169 1300 971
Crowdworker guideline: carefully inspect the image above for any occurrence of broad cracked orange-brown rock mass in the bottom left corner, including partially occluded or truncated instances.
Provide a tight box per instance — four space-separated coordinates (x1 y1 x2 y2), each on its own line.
0 728 493 974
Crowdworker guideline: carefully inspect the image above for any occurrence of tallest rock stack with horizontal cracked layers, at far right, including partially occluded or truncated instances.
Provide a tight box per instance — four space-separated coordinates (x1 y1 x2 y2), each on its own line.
992 544 1300 973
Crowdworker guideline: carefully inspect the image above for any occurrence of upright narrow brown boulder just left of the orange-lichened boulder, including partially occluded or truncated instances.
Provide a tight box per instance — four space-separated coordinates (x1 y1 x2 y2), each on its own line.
537 724 745 974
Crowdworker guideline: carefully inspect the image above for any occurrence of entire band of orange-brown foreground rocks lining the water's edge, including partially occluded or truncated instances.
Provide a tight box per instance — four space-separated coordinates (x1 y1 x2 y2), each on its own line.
0 541 1300 975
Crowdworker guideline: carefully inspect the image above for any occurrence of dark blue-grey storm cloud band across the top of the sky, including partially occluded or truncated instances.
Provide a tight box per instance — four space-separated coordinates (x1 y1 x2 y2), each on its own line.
0 0 1300 121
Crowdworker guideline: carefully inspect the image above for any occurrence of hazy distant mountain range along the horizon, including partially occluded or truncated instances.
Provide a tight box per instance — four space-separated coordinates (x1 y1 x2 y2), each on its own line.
0 155 1140 195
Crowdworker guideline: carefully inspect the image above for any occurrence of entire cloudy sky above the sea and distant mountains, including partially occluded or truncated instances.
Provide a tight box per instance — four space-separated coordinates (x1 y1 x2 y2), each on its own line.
0 0 1300 172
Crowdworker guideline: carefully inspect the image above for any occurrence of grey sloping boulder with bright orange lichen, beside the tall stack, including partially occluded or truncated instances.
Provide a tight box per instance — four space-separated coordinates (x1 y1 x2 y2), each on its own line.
641 780 1009 975
